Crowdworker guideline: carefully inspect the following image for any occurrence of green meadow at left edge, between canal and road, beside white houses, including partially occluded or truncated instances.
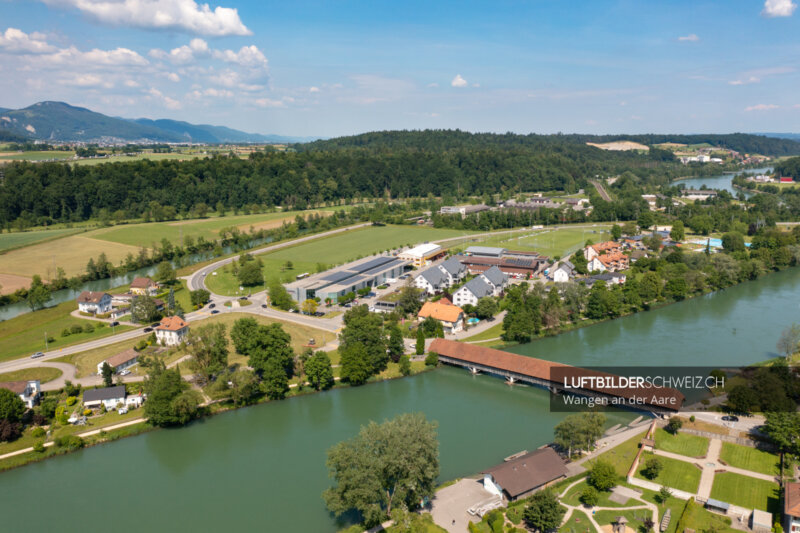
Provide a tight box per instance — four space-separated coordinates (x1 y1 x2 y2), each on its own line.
0 302 132 361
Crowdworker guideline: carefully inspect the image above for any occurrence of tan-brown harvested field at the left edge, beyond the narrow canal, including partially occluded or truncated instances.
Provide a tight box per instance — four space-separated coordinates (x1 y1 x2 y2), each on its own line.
0 234 139 279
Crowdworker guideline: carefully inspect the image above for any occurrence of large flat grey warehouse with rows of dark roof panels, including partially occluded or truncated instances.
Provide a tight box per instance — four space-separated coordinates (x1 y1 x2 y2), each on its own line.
286 256 409 302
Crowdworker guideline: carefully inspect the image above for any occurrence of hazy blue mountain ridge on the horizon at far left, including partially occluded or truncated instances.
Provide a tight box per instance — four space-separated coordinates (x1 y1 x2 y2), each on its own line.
0 102 308 144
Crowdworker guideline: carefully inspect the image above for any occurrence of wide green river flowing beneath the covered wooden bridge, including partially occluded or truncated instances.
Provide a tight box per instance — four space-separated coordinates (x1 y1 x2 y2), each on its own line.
0 269 800 532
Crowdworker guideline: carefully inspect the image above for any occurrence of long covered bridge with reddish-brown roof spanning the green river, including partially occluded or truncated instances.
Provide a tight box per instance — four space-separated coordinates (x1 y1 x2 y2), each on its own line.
429 339 686 415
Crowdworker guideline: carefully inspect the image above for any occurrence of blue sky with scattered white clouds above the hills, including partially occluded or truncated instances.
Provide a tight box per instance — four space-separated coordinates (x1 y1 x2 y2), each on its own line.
0 0 800 137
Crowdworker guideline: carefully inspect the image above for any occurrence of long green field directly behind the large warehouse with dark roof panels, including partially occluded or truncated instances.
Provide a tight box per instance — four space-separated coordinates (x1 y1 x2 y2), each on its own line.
206 226 478 296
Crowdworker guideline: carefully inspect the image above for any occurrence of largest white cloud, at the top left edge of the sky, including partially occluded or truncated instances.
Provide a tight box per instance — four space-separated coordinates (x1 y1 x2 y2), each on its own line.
41 0 252 37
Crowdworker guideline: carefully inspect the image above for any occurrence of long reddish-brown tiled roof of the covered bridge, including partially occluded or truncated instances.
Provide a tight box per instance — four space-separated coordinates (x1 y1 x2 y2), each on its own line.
429 339 685 411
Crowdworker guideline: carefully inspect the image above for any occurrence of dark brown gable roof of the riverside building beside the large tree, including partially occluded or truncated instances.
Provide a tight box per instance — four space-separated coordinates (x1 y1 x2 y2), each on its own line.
482 448 567 498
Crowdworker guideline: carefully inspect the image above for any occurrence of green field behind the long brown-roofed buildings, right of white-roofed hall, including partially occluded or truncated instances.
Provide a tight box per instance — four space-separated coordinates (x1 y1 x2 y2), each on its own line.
466 225 610 257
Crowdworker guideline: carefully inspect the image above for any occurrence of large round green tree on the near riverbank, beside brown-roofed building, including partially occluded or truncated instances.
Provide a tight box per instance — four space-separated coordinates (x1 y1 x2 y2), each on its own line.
323 413 439 526
